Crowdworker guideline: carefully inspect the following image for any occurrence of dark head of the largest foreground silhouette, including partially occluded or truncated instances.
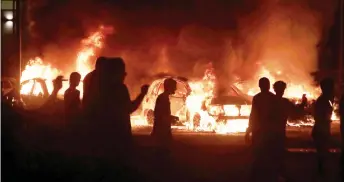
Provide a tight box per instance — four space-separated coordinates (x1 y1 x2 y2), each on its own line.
106 57 127 82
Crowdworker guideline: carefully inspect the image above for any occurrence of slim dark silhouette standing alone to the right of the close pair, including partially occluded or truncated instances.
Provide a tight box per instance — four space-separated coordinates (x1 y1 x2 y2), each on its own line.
312 78 334 175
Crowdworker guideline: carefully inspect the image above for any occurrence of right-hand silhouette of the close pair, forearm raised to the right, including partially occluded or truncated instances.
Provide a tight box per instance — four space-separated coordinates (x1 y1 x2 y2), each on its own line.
272 81 307 178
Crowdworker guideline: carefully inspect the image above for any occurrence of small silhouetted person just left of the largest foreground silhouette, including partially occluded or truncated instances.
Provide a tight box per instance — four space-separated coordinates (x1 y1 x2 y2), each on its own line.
64 72 81 121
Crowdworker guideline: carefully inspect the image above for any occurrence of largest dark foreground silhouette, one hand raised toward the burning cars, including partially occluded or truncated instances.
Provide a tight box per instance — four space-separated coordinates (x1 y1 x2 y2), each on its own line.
84 58 149 179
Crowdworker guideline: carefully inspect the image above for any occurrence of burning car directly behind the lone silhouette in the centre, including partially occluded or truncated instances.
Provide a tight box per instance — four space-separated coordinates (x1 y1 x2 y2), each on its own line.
142 76 191 124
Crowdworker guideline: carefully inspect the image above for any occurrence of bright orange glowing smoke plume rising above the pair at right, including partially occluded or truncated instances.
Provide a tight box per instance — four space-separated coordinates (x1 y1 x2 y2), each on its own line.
218 1 335 92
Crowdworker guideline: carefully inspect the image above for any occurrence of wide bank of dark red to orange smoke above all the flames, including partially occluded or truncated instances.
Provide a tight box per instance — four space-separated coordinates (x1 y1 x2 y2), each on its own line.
24 0 335 96
